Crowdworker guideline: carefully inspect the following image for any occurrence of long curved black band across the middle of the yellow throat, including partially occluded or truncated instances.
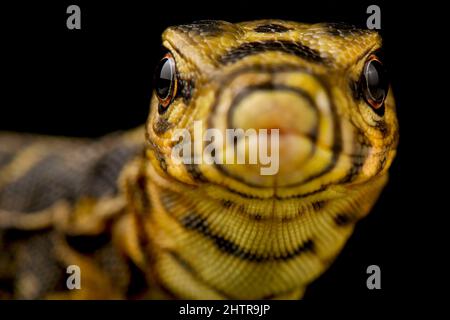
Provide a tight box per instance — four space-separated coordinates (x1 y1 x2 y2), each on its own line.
180 213 315 262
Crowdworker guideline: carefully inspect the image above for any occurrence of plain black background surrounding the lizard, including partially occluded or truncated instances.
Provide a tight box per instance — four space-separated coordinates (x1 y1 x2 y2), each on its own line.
0 0 440 299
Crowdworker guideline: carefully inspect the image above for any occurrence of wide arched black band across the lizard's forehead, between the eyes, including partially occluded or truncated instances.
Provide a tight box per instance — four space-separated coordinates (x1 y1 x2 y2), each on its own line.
219 40 327 64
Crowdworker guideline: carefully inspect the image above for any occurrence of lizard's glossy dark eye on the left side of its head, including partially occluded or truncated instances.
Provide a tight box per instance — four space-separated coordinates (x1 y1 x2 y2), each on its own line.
154 53 177 114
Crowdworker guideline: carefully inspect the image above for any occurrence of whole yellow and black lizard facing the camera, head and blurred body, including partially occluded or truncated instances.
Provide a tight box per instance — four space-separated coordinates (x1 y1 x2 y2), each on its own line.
0 20 398 299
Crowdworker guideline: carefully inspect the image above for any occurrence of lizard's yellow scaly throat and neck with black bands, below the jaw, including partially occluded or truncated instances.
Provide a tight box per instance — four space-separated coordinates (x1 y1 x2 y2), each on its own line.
119 151 386 299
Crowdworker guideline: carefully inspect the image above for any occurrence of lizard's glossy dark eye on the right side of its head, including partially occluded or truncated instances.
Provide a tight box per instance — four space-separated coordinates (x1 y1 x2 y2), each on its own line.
361 55 389 116
